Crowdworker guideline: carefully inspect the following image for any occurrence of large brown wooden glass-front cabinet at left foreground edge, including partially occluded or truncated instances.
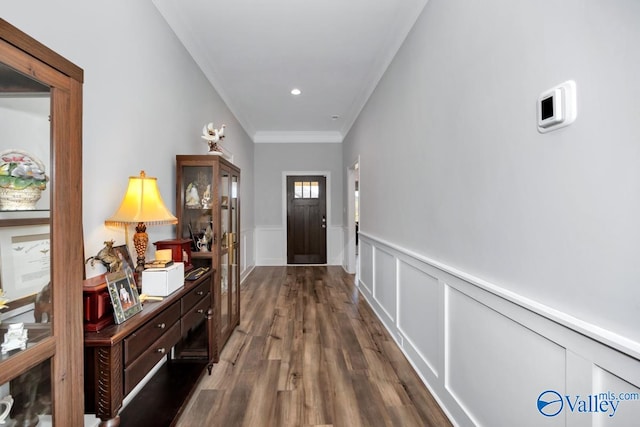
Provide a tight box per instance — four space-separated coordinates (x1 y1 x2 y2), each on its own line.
0 19 84 426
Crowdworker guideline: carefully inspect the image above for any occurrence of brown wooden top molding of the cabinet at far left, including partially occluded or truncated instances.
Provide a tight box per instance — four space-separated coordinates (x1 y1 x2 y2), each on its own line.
0 18 84 83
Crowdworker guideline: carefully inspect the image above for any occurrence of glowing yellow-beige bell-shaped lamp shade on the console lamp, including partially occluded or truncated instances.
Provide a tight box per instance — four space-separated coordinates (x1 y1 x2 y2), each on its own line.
104 171 178 226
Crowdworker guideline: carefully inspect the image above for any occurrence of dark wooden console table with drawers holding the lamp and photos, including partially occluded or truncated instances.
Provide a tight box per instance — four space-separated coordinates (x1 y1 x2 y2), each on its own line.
84 271 218 427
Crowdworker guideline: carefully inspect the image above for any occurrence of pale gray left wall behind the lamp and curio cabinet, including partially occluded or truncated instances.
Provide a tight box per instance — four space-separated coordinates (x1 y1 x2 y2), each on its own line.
2 0 254 275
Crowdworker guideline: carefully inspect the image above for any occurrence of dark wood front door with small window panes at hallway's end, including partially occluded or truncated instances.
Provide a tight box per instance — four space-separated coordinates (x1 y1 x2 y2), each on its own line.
287 176 327 264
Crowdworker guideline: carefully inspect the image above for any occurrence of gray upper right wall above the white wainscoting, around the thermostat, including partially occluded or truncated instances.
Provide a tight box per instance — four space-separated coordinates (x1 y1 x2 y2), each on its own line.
344 0 640 342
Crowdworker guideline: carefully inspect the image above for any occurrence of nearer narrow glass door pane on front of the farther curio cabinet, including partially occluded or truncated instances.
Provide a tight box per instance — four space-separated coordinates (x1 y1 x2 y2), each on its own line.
219 167 233 335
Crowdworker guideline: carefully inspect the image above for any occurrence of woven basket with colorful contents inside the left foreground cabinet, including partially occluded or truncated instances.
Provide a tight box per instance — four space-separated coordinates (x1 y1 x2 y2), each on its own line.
0 150 49 211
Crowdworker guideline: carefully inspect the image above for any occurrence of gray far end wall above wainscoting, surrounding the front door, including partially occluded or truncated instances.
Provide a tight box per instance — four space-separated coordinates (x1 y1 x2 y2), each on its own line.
255 143 343 226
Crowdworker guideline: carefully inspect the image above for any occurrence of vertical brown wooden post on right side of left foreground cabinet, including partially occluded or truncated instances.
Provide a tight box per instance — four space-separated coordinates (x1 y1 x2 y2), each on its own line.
51 79 84 425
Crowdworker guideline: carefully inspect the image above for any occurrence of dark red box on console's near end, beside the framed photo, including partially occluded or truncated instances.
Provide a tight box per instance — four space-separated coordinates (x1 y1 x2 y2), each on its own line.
82 274 113 332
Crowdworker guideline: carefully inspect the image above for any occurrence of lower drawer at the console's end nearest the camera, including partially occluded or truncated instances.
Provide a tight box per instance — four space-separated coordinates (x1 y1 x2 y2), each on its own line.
124 322 180 395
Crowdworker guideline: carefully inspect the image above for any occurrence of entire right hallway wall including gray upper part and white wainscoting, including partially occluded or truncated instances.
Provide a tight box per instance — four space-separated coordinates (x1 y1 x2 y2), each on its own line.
343 0 640 425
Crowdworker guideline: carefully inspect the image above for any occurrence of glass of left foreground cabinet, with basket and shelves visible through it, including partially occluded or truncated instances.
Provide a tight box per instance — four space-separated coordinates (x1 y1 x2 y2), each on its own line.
0 58 53 425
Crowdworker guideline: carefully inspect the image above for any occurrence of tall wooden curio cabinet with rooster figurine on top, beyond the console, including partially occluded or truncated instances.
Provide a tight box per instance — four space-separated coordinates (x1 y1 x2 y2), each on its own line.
176 155 240 361
